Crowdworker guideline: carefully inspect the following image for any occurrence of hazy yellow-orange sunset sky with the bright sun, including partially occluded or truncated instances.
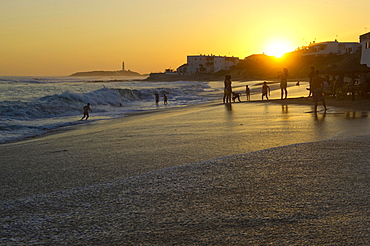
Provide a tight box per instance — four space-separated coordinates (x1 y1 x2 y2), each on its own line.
0 0 370 76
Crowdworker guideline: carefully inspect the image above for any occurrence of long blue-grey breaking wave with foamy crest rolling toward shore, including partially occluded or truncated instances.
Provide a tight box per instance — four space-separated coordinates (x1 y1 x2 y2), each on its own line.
0 84 211 119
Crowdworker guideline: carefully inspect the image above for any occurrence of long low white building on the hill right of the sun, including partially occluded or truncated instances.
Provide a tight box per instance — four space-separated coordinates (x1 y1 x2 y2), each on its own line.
303 40 360 55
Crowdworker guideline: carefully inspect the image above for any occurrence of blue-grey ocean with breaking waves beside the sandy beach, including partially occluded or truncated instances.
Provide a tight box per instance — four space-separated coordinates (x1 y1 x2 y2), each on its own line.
0 76 307 143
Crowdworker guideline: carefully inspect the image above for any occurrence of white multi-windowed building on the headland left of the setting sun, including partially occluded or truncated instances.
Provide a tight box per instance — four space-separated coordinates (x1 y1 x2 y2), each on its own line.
186 55 239 73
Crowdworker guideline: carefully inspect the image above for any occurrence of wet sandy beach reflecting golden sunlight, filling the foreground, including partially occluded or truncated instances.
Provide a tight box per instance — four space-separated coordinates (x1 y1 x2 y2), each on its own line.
0 95 370 245
